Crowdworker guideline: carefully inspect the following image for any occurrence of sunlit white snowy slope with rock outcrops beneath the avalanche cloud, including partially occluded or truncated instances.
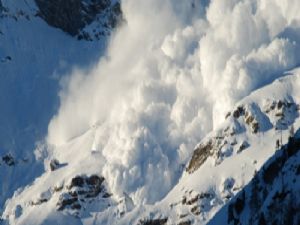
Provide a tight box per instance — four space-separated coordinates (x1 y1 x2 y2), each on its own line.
3 69 300 224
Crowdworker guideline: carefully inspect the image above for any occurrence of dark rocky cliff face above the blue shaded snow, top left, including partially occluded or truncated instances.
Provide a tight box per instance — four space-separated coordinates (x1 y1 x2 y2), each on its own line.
35 0 121 39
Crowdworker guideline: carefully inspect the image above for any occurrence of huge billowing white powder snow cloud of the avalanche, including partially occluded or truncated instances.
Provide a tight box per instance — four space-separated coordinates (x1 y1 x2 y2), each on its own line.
47 0 300 204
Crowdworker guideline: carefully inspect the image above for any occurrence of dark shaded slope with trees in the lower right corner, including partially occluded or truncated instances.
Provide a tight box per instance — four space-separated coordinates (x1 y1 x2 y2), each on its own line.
209 130 300 225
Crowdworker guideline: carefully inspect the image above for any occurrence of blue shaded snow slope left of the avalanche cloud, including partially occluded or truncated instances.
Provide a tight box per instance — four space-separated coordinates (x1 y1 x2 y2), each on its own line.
0 0 119 214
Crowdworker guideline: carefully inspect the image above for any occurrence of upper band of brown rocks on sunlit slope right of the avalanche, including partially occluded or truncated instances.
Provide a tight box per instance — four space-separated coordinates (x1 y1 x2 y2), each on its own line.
186 100 299 173
